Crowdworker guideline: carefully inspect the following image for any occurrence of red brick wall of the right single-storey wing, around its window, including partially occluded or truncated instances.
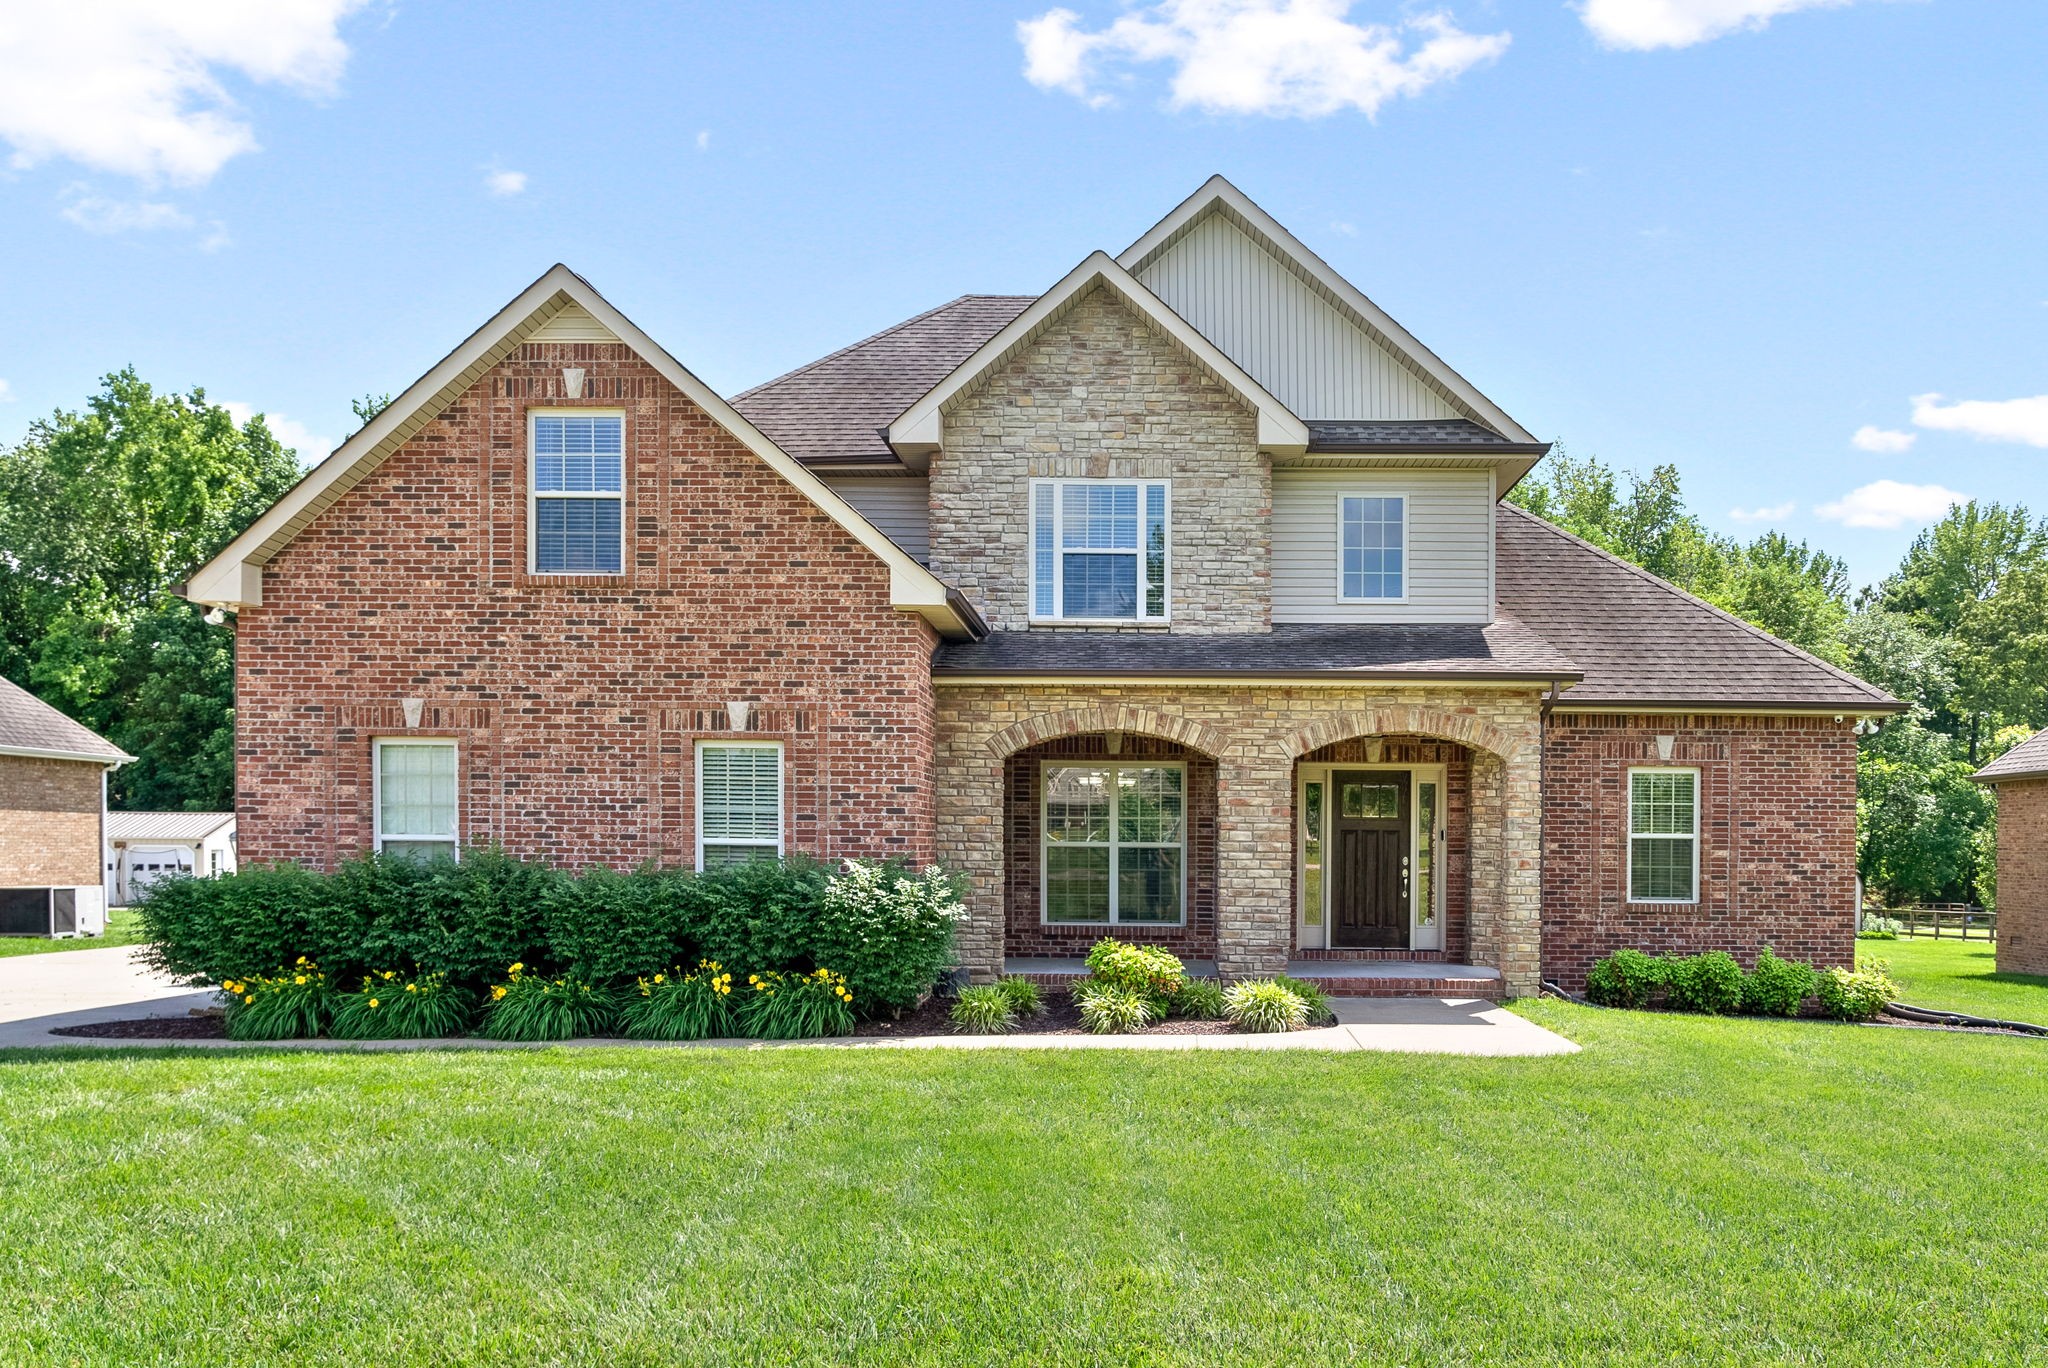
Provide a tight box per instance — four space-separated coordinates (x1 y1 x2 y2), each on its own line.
1542 713 1855 987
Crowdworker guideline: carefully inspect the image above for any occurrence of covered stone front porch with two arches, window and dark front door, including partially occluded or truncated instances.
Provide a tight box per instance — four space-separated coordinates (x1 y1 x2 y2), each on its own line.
938 688 1540 999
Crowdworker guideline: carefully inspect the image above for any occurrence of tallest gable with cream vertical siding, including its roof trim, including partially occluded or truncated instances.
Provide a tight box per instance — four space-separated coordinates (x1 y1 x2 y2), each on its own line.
1116 176 1536 442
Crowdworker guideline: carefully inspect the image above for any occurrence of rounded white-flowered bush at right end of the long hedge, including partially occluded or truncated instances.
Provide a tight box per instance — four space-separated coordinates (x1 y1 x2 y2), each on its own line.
811 860 967 1014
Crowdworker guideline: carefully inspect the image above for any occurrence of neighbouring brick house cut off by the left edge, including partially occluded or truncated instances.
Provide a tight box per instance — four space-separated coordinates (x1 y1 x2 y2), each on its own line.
0 680 133 936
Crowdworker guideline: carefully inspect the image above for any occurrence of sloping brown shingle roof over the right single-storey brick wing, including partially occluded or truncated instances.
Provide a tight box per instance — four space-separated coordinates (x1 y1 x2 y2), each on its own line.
1493 504 1903 713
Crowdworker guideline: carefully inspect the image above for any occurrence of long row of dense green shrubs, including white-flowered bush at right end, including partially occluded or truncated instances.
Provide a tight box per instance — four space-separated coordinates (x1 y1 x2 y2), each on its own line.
141 848 961 1014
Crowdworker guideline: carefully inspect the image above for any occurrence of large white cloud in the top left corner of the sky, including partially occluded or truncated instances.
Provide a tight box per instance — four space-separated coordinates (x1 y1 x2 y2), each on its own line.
0 0 367 184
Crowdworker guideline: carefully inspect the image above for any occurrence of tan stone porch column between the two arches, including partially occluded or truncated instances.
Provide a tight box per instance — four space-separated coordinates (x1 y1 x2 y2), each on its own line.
1217 754 1294 979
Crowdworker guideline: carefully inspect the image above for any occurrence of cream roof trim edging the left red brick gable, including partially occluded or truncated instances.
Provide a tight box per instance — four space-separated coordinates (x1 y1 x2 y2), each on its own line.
184 264 975 635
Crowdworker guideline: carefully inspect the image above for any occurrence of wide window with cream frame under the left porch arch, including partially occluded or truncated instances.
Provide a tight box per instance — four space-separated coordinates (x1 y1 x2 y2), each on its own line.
1042 764 1188 926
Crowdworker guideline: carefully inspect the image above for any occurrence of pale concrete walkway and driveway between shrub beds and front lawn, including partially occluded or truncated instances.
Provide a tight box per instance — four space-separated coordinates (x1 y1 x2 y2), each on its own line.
0 946 1579 1057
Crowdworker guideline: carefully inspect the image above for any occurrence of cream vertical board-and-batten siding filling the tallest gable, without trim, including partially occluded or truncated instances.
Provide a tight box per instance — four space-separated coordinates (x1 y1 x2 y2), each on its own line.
1137 213 1464 422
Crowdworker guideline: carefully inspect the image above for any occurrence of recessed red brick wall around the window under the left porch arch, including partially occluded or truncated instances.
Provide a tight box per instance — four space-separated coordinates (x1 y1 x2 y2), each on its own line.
1004 735 1217 960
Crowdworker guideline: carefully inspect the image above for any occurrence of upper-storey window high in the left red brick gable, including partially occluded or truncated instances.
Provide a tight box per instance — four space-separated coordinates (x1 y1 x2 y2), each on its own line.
530 412 627 575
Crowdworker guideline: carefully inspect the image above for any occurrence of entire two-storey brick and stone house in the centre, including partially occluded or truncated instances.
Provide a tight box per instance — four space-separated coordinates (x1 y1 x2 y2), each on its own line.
186 178 1898 993
